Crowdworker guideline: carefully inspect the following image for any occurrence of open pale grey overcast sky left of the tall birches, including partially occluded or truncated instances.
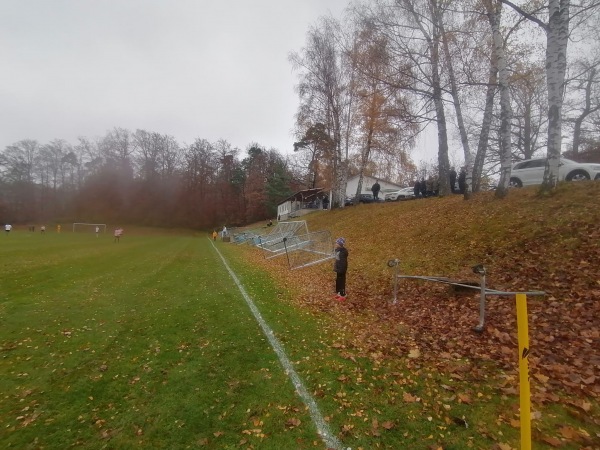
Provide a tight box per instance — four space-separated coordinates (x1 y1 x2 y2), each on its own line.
0 0 360 157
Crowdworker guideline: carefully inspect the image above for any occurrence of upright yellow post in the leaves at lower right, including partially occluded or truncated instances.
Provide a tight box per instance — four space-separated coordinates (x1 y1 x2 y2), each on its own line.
517 294 531 450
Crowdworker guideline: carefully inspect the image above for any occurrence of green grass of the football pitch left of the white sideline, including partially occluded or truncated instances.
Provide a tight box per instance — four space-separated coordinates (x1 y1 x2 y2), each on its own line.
0 232 326 448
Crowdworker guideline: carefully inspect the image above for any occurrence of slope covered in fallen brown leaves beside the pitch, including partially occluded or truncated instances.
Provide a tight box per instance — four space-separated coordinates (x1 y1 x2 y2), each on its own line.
245 182 600 402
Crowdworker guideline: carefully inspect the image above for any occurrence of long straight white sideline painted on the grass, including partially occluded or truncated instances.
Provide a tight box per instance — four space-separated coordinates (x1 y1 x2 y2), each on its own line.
209 239 342 450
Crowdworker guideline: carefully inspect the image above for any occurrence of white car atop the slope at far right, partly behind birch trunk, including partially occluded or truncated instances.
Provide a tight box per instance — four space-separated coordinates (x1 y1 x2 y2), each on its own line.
510 158 600 187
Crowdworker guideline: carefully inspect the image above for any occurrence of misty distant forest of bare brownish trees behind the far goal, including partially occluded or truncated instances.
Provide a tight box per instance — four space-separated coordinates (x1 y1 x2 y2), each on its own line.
0 128 304 230
